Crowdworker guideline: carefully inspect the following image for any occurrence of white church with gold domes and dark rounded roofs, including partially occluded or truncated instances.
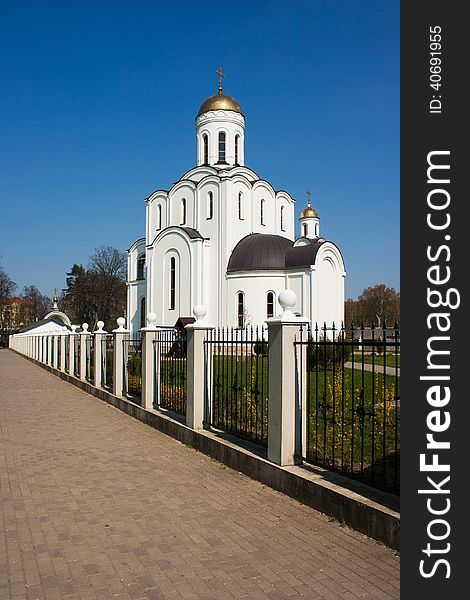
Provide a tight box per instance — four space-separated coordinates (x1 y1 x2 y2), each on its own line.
127 71 346 332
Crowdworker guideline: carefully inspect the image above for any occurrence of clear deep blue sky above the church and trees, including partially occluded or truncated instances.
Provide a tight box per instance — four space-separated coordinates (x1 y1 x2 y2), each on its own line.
0 0 399 298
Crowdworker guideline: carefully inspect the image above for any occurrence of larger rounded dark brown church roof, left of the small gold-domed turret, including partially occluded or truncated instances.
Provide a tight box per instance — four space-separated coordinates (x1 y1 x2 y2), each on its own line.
227 233 292 273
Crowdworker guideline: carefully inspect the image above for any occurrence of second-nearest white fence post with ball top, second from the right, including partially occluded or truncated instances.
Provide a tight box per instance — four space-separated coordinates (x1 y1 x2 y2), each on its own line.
186 304 214 429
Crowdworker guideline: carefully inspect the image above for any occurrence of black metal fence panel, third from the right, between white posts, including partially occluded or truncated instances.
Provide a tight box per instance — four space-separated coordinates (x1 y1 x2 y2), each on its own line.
153 329 187 416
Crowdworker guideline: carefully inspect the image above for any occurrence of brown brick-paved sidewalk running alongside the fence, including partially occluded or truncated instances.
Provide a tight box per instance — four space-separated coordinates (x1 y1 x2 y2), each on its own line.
0 350 399 600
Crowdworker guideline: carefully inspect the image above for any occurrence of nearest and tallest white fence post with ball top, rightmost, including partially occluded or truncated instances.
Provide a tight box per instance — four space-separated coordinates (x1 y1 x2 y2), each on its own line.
267 290 309 466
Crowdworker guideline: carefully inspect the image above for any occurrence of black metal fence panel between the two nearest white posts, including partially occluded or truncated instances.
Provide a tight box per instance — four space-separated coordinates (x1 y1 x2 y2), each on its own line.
204 327 268 444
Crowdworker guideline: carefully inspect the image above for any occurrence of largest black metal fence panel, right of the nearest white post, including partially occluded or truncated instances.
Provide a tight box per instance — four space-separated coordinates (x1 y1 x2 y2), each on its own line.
295 325 400 493
